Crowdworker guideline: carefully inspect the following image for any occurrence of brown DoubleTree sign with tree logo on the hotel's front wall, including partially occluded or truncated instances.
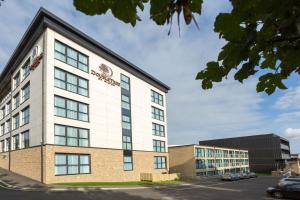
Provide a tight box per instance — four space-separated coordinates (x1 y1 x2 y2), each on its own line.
91 64 120 86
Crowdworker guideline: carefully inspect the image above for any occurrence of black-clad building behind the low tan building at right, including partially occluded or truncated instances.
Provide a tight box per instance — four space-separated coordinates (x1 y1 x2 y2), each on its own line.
199 134 290 173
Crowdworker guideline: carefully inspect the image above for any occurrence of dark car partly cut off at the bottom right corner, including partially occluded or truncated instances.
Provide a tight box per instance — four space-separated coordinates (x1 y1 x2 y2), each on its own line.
267 183 300 199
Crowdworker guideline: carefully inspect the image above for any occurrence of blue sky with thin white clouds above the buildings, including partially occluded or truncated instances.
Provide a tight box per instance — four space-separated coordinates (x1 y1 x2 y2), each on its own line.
0 0 300 153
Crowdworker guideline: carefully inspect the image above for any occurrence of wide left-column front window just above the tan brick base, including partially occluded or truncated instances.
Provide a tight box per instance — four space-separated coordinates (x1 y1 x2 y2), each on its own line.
54 124 89 147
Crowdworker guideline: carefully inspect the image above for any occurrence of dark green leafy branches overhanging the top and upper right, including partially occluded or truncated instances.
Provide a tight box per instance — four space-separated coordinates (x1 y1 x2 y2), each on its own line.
74 0 300 95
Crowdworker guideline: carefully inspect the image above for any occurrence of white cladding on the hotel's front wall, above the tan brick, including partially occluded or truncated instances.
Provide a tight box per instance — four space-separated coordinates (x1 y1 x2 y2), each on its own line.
46 28 168 151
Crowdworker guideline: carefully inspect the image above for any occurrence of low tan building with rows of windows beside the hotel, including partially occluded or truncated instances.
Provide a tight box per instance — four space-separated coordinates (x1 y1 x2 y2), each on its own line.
169 144 249 177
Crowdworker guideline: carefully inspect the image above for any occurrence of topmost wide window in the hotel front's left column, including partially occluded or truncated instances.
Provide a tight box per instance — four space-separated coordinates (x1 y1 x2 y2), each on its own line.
54 41 89 72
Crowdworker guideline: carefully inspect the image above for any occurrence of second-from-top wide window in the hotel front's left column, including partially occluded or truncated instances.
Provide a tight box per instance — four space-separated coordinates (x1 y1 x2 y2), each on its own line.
54 68 88 96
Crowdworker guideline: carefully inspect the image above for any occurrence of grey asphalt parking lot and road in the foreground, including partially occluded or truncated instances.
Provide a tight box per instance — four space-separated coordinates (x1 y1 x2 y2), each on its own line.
0 177 278 200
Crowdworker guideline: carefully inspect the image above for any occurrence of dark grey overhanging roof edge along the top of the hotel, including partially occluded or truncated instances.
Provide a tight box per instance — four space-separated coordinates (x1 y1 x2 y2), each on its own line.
0 8 170 92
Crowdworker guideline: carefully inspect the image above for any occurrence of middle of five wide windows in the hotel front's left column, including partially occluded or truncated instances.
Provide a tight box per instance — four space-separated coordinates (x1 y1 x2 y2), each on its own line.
54 96 89 121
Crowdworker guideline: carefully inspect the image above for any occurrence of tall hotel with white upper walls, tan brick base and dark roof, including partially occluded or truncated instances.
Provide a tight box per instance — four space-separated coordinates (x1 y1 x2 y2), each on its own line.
0 8 170 183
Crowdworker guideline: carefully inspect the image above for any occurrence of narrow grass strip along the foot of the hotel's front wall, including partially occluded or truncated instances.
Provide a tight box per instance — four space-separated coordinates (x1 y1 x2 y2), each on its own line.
55 181 183 187
